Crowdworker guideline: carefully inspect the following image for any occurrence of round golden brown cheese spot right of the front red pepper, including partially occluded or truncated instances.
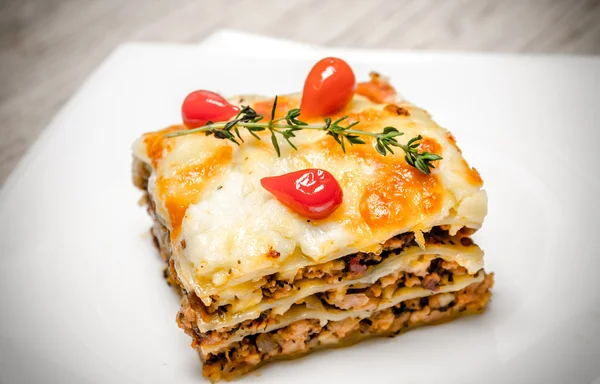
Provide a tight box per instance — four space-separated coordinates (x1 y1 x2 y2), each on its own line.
359 163 443 229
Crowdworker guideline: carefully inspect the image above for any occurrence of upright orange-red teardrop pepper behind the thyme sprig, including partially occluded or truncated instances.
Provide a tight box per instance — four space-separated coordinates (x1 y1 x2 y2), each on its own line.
300 57 356 117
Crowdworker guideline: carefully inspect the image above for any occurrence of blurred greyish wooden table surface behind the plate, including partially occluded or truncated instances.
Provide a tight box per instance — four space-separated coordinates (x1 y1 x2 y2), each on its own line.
0 0 600 184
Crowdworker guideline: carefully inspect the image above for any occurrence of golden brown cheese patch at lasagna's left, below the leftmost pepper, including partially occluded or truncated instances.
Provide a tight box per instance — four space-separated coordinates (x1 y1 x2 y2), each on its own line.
156 146 232 240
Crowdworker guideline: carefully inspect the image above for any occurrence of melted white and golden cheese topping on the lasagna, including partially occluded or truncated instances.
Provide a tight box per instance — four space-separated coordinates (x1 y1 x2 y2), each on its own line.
134 95 487 298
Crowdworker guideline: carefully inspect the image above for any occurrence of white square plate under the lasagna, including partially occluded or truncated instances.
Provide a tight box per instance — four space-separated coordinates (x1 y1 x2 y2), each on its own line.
0 40 600 383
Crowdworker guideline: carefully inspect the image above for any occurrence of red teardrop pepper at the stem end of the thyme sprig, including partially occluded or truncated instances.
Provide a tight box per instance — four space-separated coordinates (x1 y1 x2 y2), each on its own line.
181 90 240 128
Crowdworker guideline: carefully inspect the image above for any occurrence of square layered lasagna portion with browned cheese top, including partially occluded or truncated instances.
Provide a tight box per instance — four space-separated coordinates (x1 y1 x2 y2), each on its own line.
134 85 492 380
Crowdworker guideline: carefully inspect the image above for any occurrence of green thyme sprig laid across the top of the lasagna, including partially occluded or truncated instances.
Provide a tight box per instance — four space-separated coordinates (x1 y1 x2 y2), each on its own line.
165 96 442 174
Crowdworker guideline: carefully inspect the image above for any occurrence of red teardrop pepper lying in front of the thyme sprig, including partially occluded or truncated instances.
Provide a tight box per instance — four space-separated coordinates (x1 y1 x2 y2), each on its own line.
260 169 343 219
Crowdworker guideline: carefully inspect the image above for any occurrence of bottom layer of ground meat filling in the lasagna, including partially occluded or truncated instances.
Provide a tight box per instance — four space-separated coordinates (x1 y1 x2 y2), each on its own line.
200 275 493 380
